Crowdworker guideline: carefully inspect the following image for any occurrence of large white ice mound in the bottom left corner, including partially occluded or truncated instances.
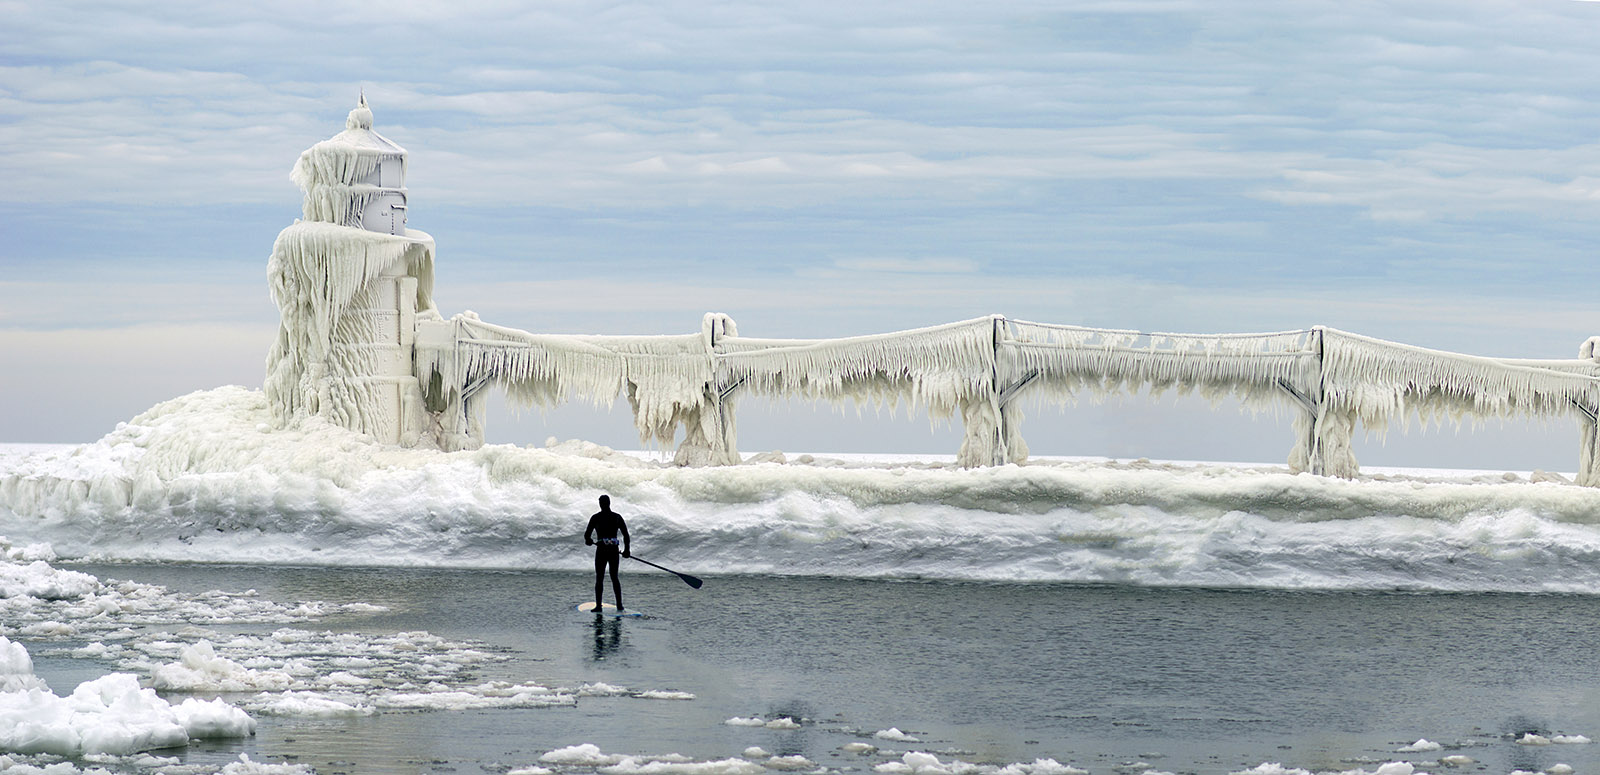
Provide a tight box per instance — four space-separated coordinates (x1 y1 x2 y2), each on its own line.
0 637 256 756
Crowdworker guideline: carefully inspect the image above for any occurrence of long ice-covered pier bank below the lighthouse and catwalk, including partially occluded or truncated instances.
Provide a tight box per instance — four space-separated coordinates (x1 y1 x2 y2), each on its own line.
9 388 1600 594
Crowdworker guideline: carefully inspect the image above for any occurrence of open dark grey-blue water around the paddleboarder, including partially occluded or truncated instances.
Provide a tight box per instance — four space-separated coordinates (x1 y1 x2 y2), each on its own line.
28 565 1600 775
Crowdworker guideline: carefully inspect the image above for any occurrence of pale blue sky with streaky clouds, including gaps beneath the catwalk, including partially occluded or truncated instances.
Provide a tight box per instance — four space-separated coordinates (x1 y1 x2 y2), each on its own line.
0 0 1600 471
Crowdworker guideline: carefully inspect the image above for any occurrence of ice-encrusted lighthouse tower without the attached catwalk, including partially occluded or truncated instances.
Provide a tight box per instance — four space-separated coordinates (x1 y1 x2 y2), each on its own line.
264 94 438 445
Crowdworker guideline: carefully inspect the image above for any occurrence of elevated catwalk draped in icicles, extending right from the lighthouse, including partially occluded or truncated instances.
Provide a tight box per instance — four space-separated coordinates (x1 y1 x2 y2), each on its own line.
416 314 1600 485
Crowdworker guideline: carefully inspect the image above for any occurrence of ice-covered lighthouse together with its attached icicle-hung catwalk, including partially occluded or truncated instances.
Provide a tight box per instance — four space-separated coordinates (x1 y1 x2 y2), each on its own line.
266 98 1600 485
